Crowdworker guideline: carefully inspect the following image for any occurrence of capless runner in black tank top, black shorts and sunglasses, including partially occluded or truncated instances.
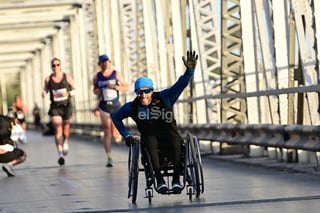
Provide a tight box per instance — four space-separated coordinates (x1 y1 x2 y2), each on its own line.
42 58 75 166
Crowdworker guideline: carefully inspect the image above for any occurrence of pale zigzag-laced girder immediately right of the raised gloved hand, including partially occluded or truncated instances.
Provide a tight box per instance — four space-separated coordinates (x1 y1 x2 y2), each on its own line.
191 0 221 123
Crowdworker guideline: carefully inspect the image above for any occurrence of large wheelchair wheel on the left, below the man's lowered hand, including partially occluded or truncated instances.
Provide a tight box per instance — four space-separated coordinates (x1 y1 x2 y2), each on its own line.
128 138 140 203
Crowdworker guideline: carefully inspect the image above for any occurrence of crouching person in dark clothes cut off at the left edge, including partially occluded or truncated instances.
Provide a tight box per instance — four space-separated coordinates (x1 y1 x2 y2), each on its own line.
0 115 27 177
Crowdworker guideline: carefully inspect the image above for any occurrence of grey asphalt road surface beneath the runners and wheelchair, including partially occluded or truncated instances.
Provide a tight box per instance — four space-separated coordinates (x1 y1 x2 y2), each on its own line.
0 130 320 213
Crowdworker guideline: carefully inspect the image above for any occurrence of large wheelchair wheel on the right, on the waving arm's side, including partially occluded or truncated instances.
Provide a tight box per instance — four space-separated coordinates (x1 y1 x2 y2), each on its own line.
187 134 204 198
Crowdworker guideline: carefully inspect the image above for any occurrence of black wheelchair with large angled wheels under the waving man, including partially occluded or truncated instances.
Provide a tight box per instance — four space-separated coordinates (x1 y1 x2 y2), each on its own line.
128 133 204 203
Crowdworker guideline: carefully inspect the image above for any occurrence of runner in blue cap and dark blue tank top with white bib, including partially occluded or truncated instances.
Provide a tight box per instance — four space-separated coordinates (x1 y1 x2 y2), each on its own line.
93 54 129 167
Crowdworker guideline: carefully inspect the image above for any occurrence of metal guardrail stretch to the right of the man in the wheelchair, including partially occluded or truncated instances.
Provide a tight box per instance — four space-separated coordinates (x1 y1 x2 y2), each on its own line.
179 123 320 152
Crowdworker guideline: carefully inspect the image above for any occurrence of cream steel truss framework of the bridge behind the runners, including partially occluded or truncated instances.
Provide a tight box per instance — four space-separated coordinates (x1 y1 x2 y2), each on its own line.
0 0 320 164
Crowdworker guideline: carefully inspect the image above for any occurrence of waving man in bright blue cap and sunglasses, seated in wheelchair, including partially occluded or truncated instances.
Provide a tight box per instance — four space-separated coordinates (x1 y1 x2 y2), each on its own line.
112 51 198 194
